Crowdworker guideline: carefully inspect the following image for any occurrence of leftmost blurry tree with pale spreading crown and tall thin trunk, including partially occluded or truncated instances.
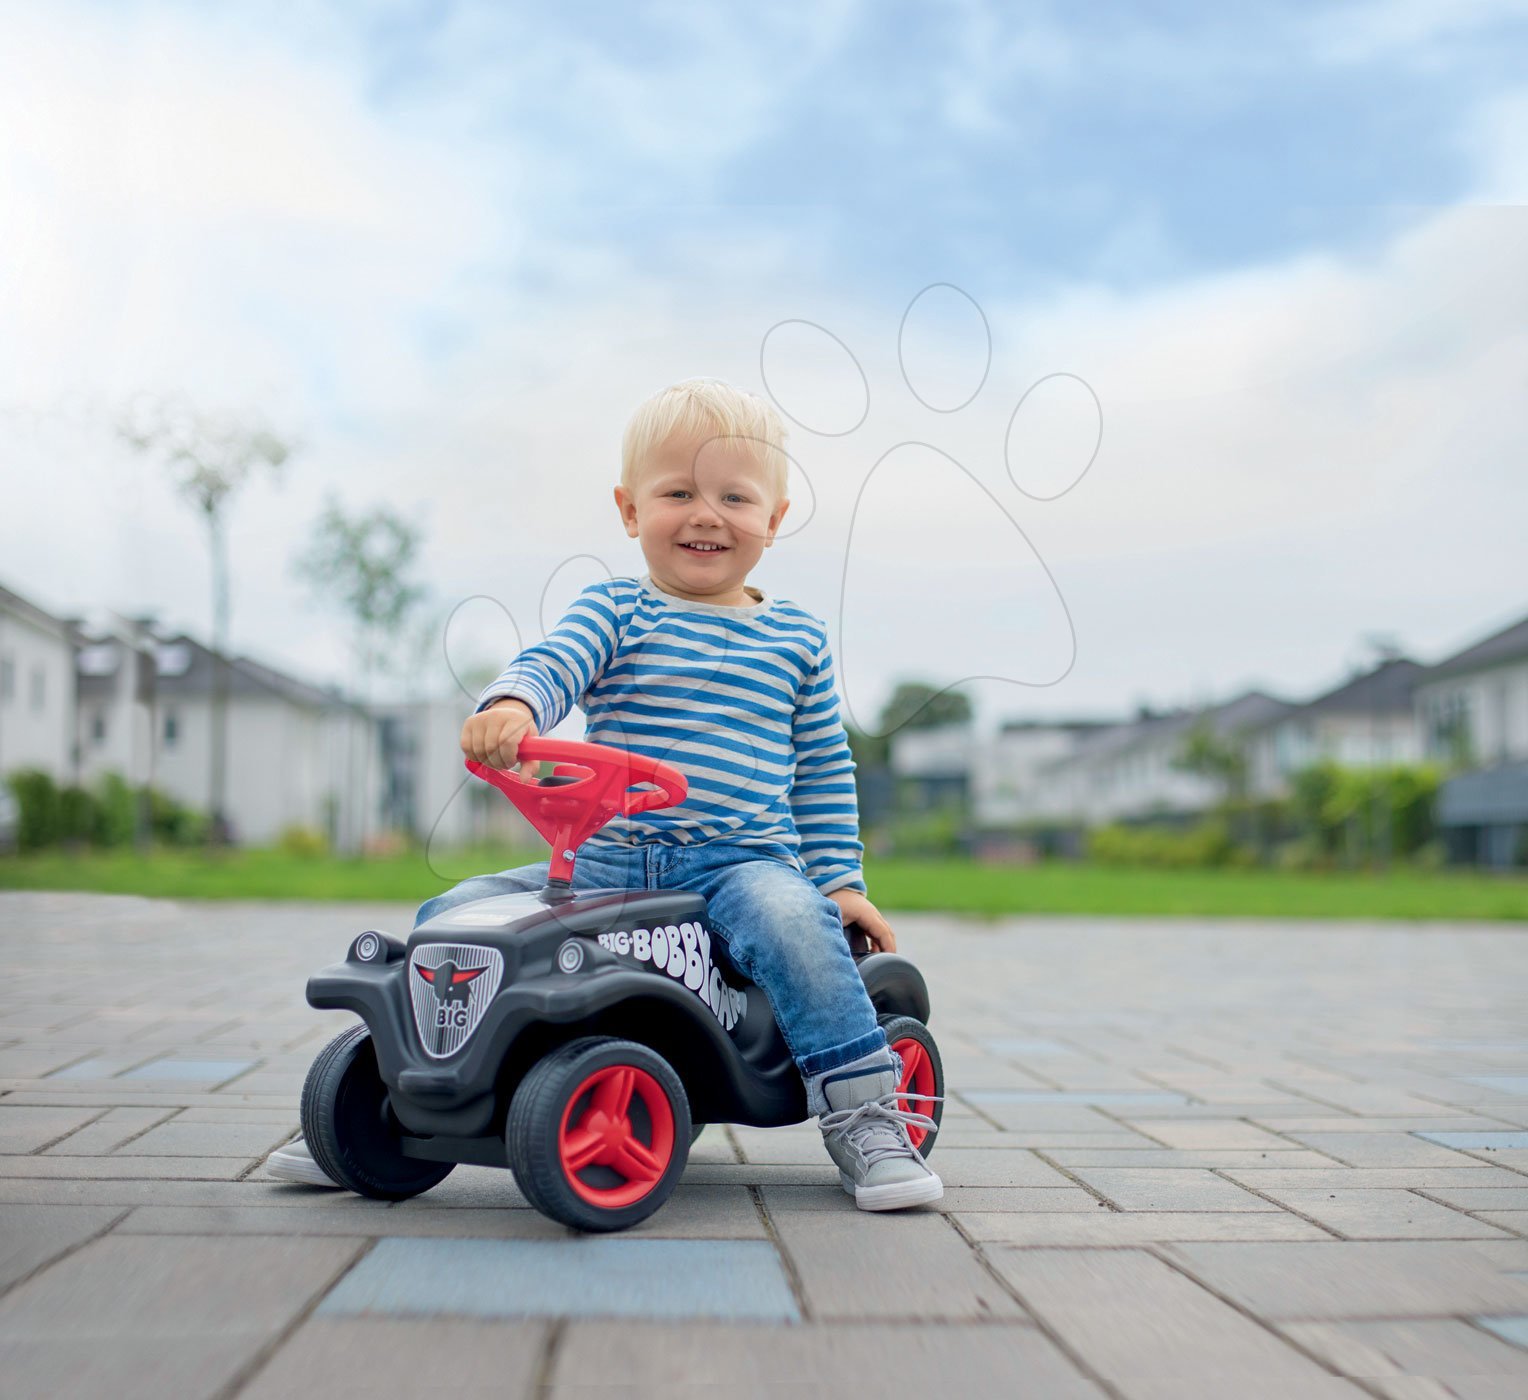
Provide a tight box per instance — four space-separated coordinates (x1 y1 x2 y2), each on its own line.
116 399 293 845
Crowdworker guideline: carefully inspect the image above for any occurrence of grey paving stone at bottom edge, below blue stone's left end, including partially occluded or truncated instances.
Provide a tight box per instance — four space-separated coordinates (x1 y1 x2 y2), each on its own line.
238 1317 547 1400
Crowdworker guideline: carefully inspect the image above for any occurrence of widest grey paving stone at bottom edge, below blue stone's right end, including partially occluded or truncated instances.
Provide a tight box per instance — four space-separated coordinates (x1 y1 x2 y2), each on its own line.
552 1322 1103 1400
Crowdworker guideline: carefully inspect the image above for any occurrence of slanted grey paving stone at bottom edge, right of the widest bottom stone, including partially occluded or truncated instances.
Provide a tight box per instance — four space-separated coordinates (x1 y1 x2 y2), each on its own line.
989 1246 1363 1400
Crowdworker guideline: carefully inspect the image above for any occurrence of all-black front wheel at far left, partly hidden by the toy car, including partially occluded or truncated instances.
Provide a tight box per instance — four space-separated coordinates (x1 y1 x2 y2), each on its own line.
303 1026 452 1201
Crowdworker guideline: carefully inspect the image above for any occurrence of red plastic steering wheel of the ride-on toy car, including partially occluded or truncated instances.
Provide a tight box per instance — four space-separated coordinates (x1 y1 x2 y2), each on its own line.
466 735 689 883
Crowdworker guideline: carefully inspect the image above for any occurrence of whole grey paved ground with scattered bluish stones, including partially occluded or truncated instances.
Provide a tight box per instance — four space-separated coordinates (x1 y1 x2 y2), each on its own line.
0 894 1528 1400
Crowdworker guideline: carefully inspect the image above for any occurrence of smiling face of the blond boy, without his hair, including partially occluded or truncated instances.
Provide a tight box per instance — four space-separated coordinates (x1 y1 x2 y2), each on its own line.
616 434 790 607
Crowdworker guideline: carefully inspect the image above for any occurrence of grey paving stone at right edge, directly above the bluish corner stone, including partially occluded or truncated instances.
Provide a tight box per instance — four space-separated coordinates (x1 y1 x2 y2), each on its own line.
1161 1241 1528 1321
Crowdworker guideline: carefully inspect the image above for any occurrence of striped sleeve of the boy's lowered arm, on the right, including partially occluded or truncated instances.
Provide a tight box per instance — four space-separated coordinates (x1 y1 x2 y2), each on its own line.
790 633 865 894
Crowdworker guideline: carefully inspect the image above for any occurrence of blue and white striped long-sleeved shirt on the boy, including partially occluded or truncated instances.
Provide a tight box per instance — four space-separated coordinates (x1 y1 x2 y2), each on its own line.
478 575 865 894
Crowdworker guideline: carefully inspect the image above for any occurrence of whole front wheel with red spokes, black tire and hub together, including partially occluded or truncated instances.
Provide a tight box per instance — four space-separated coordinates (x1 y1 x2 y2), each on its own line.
506 1036 691 1230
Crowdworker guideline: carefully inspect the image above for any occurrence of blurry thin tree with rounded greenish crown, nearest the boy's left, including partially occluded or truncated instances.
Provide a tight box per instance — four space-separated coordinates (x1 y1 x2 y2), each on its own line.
293 497 425 850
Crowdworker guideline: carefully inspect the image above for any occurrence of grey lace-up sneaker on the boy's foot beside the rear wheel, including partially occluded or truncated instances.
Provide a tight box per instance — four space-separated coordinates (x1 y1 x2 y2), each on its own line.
808 1050 944 1210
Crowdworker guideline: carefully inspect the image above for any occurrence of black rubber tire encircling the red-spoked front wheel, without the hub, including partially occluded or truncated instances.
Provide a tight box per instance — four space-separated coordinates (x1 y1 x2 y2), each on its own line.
504 1036 691 1233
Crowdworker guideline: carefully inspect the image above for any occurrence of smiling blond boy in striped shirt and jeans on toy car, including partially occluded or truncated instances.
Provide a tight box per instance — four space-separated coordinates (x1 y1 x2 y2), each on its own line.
269 379 943 1210
